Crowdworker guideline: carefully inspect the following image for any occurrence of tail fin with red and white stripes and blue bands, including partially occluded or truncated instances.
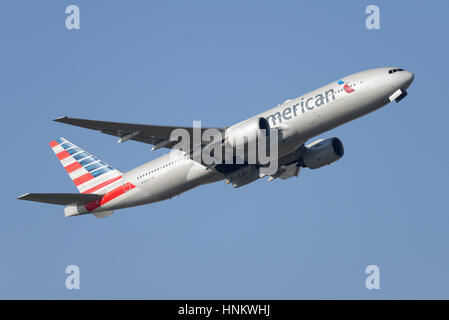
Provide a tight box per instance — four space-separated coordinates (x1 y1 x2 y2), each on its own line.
50 138 122 194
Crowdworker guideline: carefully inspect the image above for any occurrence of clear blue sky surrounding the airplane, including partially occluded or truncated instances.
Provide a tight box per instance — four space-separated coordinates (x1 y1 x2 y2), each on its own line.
0 0 449 299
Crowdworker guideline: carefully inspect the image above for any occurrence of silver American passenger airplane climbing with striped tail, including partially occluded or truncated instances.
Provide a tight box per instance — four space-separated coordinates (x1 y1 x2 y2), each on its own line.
18 67 414 218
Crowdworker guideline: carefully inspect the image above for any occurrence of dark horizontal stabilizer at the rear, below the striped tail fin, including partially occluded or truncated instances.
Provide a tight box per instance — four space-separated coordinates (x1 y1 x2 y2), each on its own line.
17 193 103 205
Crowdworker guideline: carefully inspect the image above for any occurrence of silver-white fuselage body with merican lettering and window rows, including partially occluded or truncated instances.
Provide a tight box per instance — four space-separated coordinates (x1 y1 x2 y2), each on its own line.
98 68 413 210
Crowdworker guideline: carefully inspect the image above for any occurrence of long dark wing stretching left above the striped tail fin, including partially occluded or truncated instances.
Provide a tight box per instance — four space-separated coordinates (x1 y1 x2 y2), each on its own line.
54 117 225 150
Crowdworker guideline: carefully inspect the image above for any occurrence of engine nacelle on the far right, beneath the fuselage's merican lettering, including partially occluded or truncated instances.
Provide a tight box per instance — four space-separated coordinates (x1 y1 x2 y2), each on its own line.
301 138 345 169
